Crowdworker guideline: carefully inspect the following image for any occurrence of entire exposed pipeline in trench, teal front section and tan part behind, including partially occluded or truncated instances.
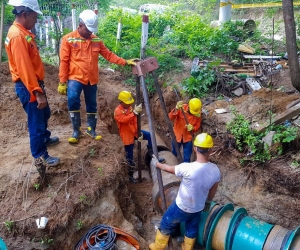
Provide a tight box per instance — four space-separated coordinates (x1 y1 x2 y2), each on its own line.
142 134 300 250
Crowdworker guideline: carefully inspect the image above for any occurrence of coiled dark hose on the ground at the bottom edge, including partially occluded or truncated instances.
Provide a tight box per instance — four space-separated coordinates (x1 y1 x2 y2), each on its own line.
73 224 116 250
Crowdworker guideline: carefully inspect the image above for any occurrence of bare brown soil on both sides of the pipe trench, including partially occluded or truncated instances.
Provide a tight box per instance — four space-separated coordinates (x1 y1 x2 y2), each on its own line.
0 62 300 249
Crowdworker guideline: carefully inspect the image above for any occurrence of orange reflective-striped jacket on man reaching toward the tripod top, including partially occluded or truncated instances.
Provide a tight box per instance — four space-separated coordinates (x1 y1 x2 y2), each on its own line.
59 30 126 85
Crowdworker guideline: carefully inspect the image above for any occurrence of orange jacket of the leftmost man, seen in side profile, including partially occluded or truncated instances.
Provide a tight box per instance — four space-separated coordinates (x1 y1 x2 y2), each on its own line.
5 21 45 102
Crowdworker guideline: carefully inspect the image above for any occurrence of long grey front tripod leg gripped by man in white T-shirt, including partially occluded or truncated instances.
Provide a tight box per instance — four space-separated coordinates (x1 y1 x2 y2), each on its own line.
140 76 167 212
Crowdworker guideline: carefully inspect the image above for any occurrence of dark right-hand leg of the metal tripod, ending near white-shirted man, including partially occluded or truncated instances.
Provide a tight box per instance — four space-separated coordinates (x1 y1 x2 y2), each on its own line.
151 71 183 163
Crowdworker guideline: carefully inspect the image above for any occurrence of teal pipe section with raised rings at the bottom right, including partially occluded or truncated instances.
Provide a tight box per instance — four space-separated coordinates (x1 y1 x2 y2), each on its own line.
180 202 300 250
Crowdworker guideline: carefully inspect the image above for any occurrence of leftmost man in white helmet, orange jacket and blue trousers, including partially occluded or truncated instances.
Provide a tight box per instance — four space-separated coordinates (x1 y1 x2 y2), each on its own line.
5 0 60 179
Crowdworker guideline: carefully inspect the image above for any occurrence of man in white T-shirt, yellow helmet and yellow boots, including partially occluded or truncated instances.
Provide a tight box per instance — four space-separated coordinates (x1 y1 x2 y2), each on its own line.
149 133 221 250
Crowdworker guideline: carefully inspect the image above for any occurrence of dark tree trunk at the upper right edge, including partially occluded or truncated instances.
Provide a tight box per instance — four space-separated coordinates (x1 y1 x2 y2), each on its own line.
282 0 300 91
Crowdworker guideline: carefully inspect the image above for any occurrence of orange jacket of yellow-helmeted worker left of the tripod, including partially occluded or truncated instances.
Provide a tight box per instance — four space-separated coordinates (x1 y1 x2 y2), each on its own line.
114 105 138 145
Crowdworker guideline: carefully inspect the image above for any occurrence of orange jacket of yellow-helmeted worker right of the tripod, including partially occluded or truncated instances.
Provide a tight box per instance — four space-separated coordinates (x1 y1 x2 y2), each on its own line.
169 104 201 143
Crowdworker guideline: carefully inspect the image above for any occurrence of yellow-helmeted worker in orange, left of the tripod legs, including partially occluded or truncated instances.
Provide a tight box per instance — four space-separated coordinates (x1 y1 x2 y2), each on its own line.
114 91 165 181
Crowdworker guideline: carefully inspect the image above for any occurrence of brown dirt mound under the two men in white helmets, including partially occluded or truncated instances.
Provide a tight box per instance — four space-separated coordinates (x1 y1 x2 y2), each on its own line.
0 63 145 249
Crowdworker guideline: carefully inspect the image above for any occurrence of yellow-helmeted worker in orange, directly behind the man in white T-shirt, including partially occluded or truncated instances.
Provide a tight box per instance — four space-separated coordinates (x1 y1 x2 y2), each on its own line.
169 98 202 162
